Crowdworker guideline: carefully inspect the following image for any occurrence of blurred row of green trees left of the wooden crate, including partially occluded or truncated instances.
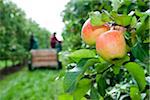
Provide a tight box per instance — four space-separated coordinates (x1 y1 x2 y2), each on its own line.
0 0 50 63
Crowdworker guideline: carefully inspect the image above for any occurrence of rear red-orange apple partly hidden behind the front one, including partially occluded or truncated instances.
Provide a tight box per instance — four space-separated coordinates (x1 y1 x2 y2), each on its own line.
81 18 110 45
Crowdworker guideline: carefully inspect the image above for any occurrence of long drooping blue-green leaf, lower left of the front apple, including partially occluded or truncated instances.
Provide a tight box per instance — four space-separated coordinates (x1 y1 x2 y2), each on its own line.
64 58 99 92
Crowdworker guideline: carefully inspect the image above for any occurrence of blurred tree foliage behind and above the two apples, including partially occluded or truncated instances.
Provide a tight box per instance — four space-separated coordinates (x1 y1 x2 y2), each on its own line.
62 0 149 50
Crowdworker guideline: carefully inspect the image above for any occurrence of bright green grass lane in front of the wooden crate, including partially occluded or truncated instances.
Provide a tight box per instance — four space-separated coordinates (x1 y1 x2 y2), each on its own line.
0 68 64 100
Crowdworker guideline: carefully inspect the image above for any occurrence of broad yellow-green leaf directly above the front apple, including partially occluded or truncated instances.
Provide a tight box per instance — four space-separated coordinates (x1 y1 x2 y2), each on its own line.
111 12 132 26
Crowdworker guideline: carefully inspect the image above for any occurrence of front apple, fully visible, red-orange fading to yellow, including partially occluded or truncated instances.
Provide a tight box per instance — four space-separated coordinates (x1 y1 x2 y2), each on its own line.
96 30 126 62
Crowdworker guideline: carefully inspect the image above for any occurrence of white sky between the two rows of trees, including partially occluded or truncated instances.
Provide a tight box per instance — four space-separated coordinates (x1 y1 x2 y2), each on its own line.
11 0 69 40
